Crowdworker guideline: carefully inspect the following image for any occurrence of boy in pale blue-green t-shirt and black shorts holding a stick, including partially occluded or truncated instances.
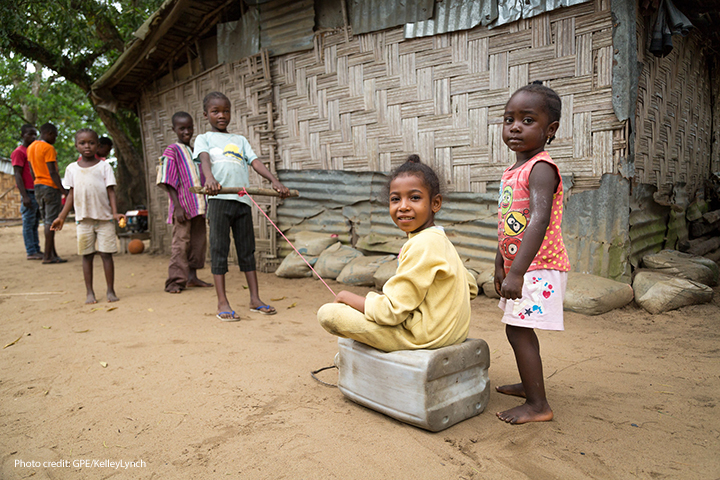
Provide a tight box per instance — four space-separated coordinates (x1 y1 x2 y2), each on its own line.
193 92 290 322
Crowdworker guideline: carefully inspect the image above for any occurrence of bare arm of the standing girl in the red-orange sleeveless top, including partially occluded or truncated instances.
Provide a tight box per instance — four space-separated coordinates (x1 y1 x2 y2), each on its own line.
495 162 560 300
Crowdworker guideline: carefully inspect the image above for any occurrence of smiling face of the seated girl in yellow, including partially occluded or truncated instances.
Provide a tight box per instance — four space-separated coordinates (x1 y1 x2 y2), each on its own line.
390 174 442 233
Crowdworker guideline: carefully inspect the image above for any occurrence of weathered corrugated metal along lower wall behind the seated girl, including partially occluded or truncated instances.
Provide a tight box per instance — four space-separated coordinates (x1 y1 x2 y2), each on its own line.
278 170 497 267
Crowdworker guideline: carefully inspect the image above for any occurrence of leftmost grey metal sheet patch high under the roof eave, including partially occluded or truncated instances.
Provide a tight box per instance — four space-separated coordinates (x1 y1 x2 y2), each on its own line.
217 8 260 63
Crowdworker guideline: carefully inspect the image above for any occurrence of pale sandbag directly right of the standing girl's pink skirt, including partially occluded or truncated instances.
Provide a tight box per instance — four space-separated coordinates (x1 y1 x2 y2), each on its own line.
563 272 633 315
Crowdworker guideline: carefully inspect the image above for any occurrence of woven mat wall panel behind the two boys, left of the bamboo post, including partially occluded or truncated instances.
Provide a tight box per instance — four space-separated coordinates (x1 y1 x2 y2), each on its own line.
140 53 277 270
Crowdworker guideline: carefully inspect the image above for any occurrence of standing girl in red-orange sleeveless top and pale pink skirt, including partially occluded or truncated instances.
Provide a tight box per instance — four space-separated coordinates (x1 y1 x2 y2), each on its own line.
495 83 570 423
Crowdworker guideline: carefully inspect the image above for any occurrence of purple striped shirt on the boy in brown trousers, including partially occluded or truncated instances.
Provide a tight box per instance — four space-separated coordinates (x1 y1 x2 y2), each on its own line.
156 143 207 223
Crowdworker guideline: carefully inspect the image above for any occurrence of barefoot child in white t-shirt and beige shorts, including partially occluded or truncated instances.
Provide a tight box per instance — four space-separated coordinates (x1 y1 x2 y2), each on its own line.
51 128 125 303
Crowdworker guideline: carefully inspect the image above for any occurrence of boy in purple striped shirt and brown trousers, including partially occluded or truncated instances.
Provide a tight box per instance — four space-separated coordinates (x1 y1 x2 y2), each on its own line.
157 112 212 293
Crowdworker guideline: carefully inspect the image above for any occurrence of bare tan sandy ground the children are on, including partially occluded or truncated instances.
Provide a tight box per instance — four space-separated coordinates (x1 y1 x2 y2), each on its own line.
0 226 720 479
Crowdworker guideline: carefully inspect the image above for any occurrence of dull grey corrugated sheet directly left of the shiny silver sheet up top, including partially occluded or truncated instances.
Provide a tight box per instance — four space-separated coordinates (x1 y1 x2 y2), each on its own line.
348 0 435 35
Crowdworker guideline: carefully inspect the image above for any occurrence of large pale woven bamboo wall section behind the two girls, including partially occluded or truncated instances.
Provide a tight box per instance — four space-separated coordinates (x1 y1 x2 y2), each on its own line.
272 0 626 192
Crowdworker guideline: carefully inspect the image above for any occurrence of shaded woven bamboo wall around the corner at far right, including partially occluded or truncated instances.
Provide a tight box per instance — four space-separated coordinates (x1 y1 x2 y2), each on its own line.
635 18 717 199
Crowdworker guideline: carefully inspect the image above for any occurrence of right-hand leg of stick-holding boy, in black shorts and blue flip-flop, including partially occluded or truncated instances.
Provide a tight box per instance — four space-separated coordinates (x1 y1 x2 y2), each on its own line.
232 202 277 315
